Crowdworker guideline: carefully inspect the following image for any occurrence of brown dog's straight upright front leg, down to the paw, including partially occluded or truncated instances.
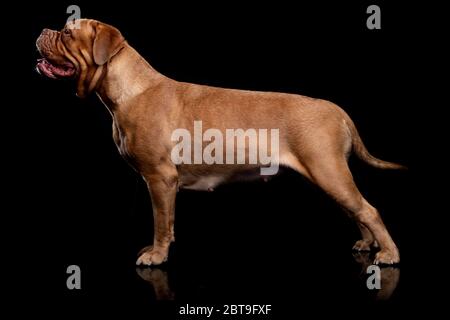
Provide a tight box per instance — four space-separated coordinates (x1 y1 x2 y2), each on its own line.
136 165 178 266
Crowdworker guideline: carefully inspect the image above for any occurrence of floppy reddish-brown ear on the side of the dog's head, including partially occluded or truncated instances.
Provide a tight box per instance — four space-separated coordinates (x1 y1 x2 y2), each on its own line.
92 23 125 66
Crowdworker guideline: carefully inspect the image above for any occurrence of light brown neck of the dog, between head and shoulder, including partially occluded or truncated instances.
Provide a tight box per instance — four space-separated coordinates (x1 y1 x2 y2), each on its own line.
96 43 167 113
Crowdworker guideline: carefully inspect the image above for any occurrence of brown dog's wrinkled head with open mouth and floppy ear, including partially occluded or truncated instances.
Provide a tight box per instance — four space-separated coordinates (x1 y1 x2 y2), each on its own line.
36 19 125 97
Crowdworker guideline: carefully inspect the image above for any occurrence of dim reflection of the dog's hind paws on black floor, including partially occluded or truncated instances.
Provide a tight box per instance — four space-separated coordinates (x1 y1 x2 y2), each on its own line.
353 252 400 300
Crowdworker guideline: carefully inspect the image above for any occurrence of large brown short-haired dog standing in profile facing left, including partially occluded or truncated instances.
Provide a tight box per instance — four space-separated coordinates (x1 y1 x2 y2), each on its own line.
36 19 402 265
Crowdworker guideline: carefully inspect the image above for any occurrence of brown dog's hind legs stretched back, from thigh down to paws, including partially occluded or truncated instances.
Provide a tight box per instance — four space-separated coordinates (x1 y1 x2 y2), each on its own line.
305 155 400 264
